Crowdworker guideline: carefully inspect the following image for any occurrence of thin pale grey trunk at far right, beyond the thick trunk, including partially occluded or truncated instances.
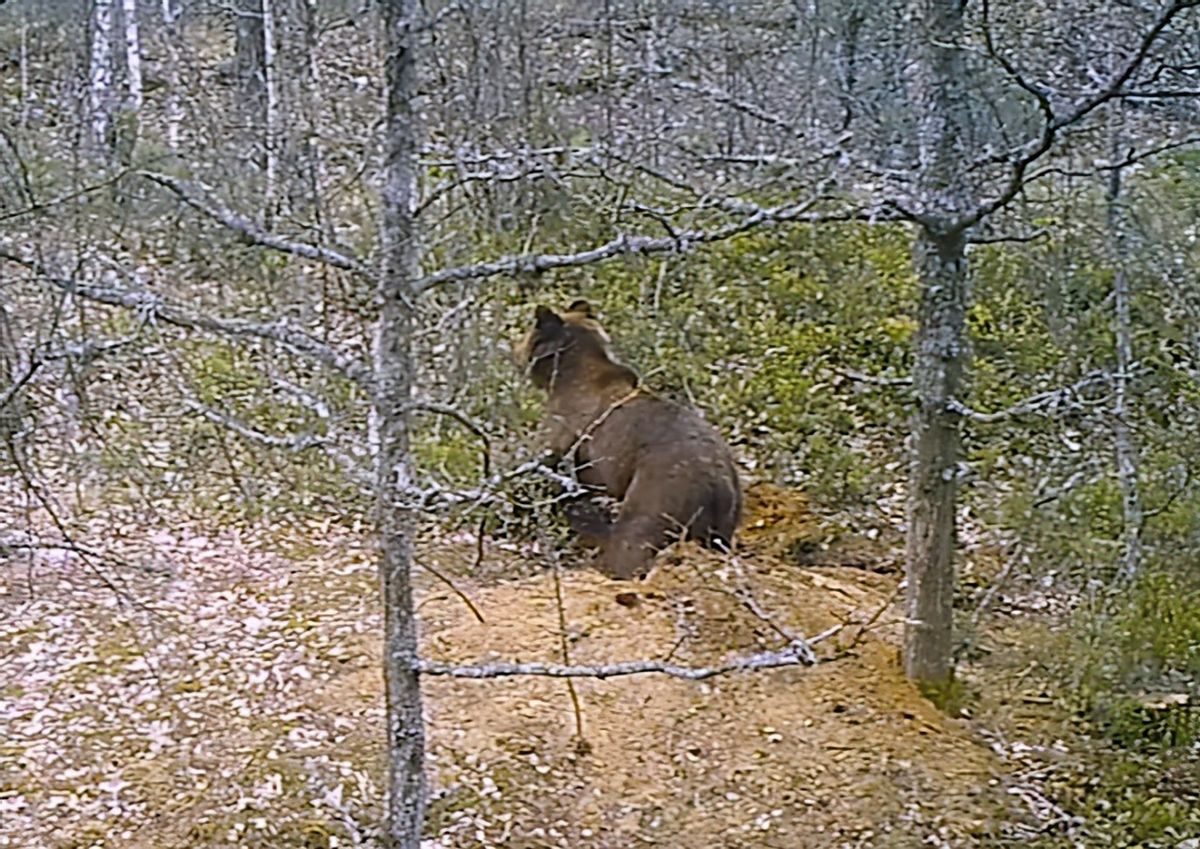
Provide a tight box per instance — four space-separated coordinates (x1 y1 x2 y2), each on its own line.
1105 101 1144 577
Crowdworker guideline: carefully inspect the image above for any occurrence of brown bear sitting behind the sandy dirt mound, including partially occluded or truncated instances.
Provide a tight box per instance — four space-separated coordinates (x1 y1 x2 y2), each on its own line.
517 301 742 580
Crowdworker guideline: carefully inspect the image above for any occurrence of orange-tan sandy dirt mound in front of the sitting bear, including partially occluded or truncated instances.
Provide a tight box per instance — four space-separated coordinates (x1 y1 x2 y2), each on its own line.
408 547 1000 847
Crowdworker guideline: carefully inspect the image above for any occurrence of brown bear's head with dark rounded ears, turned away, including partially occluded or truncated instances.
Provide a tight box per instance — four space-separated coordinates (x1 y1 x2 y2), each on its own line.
516 300 637 391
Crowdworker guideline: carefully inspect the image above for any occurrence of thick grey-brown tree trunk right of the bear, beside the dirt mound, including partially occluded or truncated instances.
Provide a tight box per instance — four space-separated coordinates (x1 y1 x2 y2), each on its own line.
904 0 970 692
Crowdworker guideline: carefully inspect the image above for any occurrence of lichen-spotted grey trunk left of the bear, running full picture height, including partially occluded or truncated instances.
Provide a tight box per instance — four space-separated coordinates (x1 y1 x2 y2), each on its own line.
373 0 425 849
